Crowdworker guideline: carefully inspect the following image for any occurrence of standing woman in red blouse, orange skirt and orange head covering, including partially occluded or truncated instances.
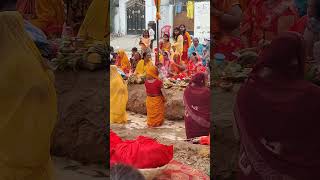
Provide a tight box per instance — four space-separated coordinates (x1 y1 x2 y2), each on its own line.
145 66 165 127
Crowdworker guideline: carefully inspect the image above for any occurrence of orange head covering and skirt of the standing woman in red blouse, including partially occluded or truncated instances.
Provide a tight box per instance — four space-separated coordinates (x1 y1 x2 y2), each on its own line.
146 66 165 127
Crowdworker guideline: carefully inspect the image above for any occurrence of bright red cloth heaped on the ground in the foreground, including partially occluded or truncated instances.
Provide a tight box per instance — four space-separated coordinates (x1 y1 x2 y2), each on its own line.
110 136 173 169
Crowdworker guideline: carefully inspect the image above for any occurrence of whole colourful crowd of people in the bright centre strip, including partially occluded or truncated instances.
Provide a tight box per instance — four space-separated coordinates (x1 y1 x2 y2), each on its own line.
110 25 210 142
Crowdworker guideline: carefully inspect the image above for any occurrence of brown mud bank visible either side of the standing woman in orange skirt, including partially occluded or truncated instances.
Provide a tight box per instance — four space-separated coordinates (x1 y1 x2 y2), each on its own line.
127 84 184 120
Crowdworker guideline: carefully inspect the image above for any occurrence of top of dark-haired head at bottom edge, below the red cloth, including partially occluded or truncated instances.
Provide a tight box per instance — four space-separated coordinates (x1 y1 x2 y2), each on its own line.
110 164 145 180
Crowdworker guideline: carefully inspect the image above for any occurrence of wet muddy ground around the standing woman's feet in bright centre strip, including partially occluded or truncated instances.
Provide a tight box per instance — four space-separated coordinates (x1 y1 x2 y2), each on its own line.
110 112 210 175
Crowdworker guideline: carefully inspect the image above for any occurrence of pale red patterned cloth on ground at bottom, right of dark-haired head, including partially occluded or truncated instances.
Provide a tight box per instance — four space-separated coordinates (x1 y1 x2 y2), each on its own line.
156 160 210 180
